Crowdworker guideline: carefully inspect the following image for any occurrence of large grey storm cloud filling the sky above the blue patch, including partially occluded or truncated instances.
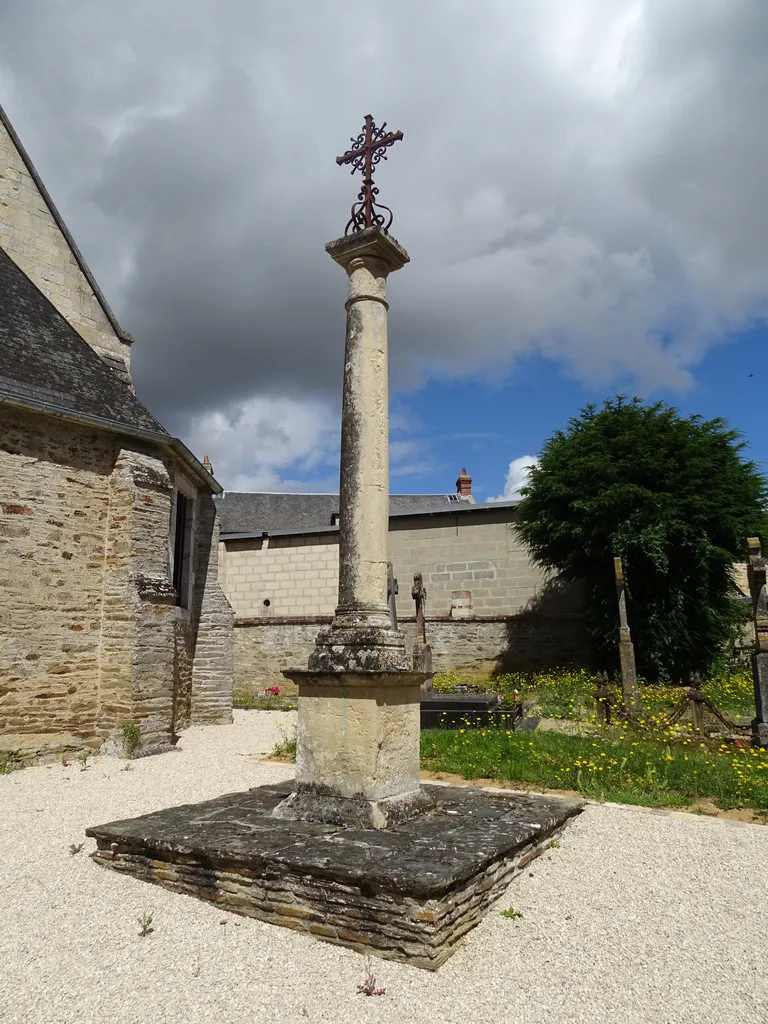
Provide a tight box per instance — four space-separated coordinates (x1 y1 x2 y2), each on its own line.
0 0 768 482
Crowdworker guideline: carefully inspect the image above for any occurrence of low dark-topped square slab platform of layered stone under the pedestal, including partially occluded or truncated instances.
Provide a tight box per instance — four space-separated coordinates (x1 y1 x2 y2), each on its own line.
86 782 584 970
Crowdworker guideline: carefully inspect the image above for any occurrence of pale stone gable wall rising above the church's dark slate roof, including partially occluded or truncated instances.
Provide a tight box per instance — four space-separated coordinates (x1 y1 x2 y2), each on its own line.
0 112 130 379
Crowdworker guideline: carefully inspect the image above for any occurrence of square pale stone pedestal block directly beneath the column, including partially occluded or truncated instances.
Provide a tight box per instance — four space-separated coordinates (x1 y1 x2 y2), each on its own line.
274 671 430 828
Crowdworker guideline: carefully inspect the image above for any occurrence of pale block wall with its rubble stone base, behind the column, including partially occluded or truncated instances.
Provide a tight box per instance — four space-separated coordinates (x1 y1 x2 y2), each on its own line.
221 508 585 692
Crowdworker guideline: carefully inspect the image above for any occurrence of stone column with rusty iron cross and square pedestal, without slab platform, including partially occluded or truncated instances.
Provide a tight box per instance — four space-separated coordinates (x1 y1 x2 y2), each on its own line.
274 115 429 828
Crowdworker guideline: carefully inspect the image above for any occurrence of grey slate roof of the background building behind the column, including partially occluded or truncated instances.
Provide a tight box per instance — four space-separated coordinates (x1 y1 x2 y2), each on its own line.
216 490 518 538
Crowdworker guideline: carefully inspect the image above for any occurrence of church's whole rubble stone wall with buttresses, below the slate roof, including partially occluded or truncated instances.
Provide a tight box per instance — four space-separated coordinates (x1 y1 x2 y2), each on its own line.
0 407 232 762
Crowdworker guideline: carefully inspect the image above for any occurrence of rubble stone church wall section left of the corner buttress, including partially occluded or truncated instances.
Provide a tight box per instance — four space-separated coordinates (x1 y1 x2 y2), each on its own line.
0 408 116 760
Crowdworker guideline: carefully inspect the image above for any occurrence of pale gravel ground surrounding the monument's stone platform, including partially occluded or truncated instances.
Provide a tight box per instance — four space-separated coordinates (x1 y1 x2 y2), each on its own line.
0 712 768 1024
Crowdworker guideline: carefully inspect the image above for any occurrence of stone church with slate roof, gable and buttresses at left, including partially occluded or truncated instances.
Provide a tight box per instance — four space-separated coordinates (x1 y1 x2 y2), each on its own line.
0 108 232 764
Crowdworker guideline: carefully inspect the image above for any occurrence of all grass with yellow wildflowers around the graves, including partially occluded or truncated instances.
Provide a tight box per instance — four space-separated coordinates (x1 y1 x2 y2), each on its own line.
264 670 768 814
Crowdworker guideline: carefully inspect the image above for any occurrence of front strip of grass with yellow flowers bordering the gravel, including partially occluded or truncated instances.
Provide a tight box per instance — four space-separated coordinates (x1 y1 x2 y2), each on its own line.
421 728 768 811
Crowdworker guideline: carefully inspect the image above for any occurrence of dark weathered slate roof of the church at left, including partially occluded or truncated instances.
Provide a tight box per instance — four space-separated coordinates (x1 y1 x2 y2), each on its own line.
0 249 171 441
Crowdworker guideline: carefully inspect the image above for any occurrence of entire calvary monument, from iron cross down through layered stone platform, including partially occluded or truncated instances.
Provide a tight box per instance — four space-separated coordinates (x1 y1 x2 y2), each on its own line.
86 115 582 969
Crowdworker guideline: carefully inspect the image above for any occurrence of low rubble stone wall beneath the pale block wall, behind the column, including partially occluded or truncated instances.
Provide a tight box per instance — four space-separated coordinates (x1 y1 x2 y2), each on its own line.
234 612 586 693
